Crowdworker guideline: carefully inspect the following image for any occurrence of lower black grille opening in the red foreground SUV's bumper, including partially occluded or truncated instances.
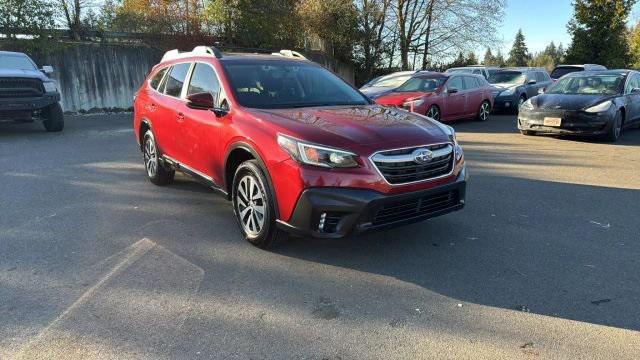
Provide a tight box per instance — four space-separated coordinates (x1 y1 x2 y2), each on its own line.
372 190 460 226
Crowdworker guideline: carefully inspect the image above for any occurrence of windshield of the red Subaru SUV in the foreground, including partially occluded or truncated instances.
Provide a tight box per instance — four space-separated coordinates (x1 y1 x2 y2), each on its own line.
223 60 369 109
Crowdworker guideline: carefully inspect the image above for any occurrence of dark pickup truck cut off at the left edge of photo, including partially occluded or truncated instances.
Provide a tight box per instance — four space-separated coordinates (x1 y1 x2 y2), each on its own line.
0 51 64 131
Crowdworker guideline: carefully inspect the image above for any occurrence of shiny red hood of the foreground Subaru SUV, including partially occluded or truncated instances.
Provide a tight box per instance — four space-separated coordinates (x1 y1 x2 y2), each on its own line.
248 105 449 152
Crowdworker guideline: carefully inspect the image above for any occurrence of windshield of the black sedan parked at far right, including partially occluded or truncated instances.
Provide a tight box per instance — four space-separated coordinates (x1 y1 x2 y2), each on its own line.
547 74 624 95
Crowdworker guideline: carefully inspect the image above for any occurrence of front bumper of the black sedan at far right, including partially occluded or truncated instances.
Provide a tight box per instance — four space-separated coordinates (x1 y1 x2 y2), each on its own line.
518 110 615 136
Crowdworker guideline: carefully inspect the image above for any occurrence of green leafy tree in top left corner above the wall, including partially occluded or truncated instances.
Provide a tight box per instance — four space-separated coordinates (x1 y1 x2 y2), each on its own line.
0 0 54 39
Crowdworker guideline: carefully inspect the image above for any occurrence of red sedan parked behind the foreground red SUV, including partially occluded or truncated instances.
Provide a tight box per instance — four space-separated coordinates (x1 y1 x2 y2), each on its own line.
376 72 493 121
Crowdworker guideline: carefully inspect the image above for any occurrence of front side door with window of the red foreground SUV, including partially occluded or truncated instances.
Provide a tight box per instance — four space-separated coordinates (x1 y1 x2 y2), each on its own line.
179 62 223 184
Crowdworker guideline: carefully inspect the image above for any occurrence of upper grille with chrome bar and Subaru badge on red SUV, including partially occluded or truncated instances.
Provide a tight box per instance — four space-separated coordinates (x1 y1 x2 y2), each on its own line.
371 144 454 185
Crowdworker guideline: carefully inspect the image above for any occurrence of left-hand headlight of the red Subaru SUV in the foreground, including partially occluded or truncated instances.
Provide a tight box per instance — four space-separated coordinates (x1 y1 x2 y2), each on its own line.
278 134 358 168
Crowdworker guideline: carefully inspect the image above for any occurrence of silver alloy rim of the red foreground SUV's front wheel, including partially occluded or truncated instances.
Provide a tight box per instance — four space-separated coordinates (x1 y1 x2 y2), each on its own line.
236 175 266 236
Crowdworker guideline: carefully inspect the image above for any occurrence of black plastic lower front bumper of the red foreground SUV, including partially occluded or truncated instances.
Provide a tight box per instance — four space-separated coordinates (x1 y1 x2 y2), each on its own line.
278 169 468 238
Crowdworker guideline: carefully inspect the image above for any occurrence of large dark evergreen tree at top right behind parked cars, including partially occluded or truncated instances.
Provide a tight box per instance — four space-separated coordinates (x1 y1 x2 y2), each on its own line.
566 0 636 68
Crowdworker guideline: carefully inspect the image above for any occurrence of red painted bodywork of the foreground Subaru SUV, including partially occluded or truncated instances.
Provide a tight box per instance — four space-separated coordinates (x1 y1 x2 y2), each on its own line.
133 51 464 236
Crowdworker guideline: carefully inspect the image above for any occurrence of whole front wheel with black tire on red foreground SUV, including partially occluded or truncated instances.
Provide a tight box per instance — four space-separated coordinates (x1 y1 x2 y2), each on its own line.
231 160 281 249
